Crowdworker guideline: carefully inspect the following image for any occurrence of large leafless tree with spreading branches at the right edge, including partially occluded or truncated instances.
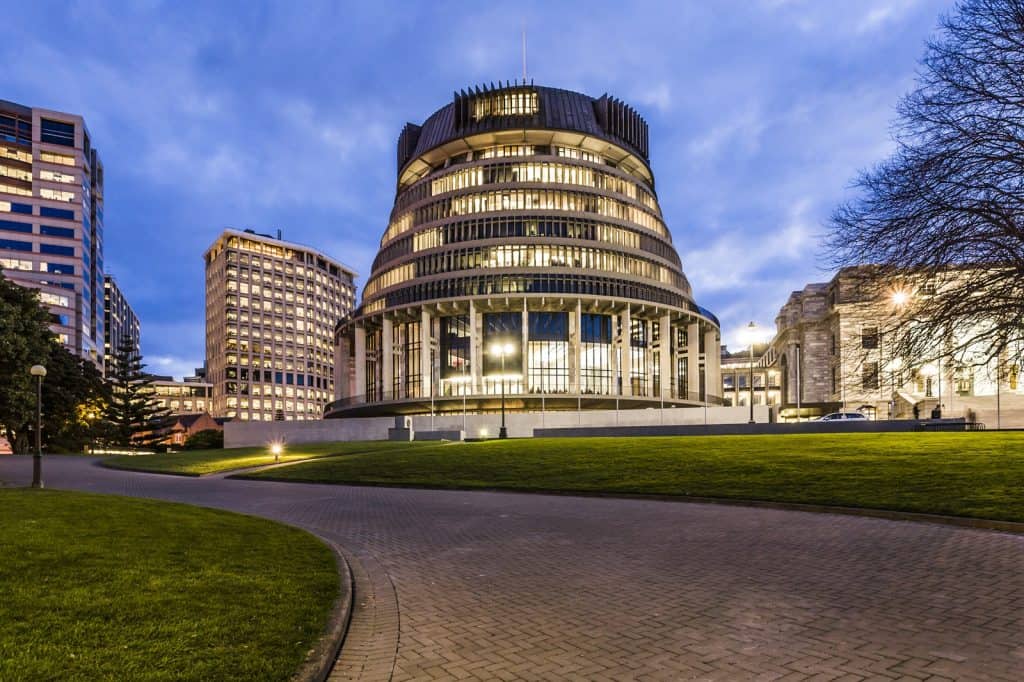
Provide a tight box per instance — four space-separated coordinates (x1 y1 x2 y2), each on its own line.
828 0 1024 364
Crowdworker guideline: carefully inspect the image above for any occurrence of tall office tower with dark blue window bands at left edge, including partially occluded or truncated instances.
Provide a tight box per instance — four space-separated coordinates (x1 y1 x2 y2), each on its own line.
0 100 103 369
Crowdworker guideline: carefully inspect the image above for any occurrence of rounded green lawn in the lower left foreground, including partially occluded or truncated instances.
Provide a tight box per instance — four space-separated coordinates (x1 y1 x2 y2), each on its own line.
0 488 338 680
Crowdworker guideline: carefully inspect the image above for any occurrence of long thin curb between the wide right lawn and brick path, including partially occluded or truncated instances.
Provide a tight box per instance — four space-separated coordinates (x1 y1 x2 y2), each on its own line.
238 475 1024 536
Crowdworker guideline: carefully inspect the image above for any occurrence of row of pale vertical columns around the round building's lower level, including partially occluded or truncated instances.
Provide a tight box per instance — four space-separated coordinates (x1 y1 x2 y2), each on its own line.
336 301 721 400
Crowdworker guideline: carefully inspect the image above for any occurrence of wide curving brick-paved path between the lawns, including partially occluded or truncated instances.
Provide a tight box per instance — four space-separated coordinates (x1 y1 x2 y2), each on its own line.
0 458 1024 680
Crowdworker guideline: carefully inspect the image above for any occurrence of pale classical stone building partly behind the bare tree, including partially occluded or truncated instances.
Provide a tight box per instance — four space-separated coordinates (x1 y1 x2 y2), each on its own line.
758 267 1024 426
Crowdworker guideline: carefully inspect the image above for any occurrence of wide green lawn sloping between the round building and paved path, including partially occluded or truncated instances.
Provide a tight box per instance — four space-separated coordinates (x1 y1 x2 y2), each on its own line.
239 432 1024 521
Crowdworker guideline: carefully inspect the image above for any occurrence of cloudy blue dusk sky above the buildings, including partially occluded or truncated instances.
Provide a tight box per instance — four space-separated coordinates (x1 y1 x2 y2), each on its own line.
6 0 952 376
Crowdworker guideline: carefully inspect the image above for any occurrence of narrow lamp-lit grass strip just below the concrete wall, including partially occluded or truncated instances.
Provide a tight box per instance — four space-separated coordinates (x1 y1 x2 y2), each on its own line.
102 441 428 476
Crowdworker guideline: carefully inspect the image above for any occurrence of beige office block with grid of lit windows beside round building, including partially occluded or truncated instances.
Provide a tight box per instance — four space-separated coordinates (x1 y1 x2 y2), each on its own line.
205 229 355 421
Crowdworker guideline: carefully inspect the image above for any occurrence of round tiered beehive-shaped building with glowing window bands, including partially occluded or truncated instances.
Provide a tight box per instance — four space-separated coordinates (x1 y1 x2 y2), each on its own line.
328 84 721 417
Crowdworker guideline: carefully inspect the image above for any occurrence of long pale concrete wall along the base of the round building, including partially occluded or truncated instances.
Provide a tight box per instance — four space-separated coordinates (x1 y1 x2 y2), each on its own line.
224 407 770 447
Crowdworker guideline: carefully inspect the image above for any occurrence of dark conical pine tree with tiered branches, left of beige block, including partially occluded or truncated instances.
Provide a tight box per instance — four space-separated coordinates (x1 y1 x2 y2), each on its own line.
106 341 170 447
